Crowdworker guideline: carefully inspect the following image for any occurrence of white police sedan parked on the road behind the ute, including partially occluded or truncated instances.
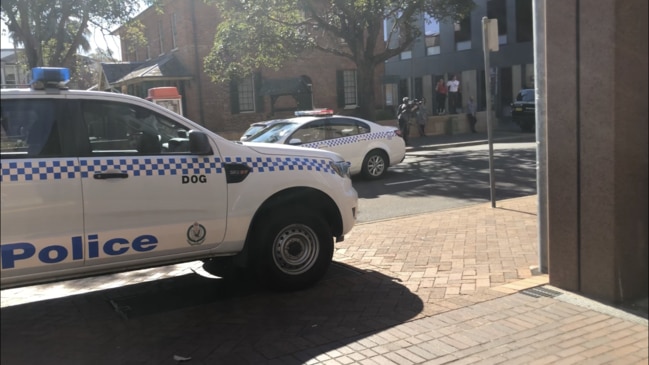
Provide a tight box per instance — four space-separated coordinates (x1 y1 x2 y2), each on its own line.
245 109 406 179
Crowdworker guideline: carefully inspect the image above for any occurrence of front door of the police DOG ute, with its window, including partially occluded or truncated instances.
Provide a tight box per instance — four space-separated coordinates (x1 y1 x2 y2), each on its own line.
79 100 227 266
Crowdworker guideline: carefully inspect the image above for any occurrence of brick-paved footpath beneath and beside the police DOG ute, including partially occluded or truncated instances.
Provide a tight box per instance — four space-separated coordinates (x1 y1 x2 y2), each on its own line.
0 196 649 365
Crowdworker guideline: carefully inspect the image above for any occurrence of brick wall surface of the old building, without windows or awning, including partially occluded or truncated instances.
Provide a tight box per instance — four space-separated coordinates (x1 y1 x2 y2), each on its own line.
122 0 383 139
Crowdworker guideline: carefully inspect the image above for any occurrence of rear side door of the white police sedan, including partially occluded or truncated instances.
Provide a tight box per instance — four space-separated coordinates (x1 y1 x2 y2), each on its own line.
327 117 370 171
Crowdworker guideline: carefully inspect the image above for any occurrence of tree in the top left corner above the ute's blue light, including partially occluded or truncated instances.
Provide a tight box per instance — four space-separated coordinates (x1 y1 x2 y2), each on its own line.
1 0 155 70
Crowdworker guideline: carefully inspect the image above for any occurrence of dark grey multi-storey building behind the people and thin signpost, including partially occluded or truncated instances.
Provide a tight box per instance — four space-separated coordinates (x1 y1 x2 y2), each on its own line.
383 0 534 116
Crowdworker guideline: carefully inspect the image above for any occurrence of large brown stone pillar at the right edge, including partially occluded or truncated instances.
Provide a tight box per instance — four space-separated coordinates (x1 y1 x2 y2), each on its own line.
535 0 649 303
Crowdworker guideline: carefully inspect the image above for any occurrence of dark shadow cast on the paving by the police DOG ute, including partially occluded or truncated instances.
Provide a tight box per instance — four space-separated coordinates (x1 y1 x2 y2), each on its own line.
1 263 423 365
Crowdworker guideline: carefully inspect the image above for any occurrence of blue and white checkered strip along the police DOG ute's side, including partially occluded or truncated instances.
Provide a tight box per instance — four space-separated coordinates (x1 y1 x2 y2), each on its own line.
0 157 335 182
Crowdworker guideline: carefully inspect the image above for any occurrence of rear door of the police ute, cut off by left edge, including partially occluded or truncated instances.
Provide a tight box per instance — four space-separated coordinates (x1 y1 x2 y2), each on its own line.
0 95 83 286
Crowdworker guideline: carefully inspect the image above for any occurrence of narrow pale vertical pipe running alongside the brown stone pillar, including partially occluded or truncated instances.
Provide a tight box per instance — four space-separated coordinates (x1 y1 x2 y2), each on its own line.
532 0 548 274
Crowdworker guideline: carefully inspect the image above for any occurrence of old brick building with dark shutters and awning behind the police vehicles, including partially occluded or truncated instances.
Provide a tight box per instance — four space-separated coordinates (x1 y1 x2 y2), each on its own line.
101 0 383 139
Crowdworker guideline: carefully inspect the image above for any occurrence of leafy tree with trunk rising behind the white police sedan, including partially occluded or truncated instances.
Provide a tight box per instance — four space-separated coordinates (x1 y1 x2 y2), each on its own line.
204 0 475 119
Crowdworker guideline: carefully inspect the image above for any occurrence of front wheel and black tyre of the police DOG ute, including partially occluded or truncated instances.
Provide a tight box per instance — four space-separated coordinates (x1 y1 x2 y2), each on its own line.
254 209 333 290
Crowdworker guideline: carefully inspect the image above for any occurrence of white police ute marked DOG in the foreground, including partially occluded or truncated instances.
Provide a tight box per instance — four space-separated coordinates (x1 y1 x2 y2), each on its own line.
0 68 358 290
